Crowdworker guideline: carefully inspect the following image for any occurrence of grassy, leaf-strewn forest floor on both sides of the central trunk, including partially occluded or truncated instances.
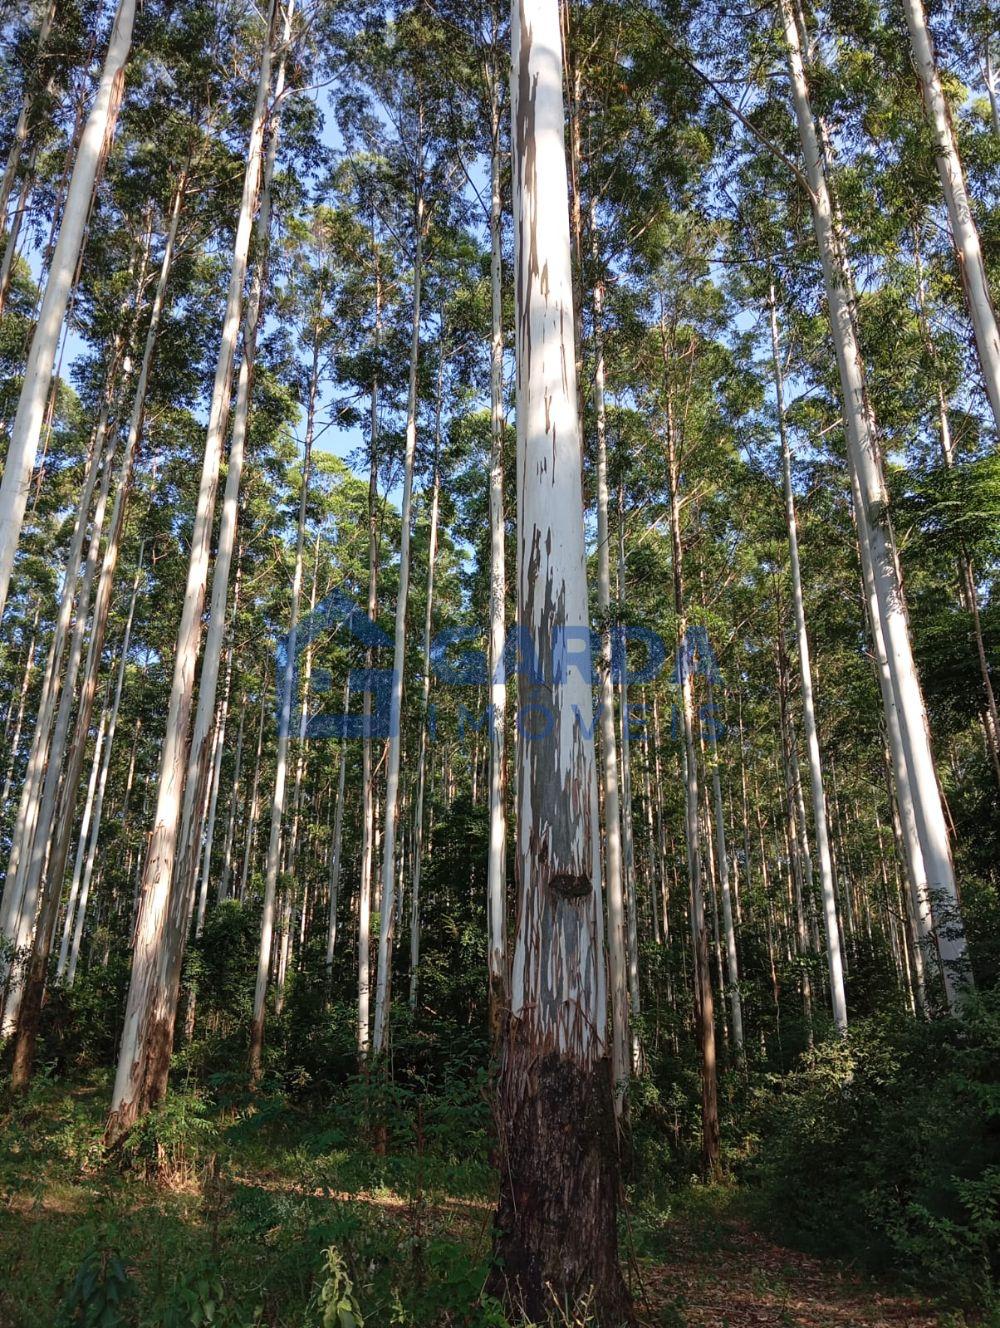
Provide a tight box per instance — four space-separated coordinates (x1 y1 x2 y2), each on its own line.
0 1078 950 1328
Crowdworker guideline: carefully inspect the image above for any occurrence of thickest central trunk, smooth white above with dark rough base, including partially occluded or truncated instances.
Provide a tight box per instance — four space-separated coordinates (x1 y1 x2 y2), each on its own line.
491 0 631 1324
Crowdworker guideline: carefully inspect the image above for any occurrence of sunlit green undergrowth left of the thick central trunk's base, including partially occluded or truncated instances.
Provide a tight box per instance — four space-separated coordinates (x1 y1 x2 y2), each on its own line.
0 1076 503 1328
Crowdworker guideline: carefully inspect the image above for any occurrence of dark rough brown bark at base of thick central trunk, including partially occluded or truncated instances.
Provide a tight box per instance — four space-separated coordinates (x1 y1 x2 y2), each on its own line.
487 1042 635 1328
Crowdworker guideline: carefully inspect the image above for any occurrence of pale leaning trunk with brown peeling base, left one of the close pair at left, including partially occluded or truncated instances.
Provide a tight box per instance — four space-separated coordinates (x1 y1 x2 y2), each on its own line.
108 0 278 1138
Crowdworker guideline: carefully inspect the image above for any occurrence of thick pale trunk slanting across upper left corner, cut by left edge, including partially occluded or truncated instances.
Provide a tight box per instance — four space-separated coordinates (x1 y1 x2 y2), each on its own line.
0 0 135 616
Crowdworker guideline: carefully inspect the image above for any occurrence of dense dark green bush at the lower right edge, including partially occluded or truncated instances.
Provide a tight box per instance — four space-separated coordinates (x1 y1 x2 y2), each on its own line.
746 993 1000 1307
